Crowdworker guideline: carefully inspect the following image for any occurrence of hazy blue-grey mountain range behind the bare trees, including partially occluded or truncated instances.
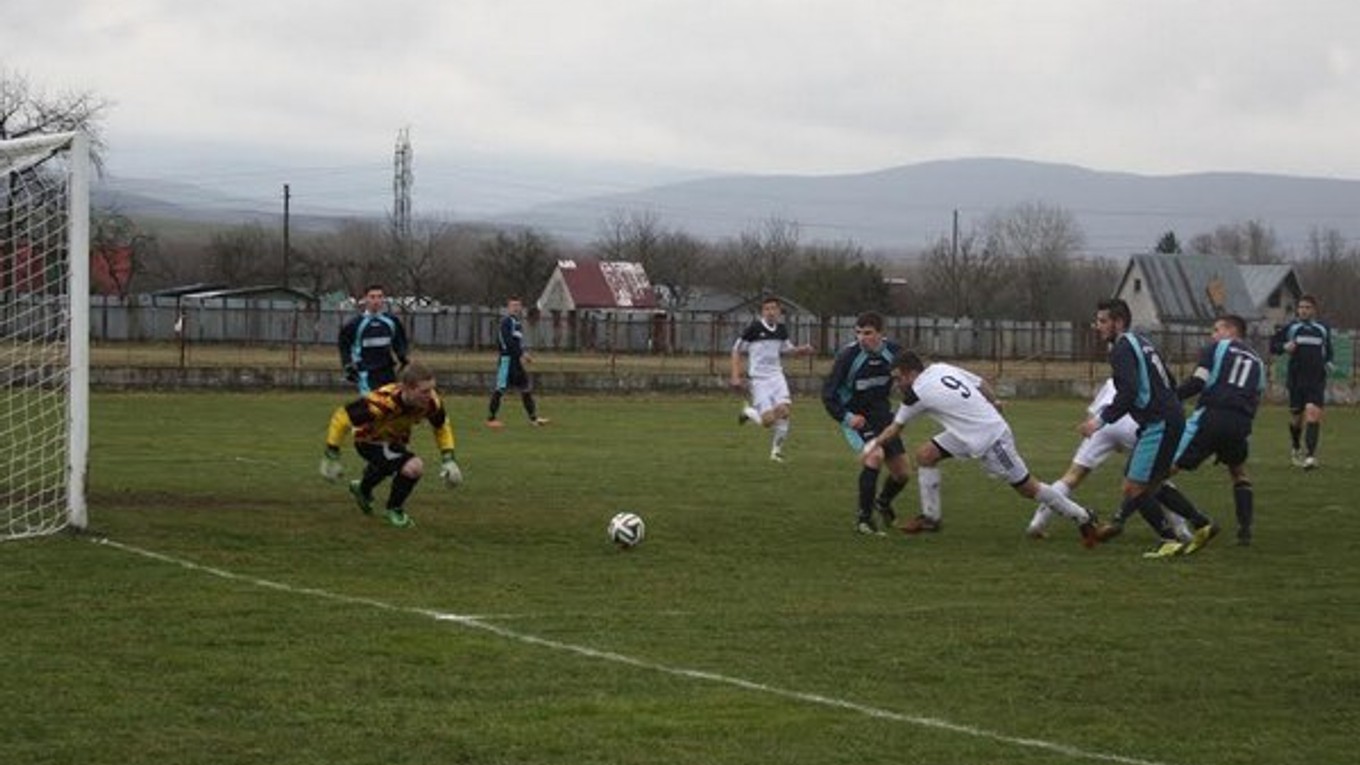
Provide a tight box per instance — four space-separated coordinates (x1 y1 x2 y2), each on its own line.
97 158 1360 259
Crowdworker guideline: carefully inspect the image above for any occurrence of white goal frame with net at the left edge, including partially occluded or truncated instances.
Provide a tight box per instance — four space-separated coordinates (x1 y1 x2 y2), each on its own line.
0 133 90 540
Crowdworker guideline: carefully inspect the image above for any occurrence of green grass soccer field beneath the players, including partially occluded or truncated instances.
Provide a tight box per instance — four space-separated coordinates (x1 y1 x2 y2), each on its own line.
0 393 1360 765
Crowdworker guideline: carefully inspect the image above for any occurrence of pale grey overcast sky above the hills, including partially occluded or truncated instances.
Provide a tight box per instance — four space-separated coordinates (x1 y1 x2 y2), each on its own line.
0 0 1360 205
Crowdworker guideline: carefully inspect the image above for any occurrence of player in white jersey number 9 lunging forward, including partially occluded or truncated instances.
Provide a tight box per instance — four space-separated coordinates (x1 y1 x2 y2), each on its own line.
864 351 1098 547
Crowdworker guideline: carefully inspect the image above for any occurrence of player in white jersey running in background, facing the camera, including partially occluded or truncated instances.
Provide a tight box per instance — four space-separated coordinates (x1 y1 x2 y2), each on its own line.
730 297 812 461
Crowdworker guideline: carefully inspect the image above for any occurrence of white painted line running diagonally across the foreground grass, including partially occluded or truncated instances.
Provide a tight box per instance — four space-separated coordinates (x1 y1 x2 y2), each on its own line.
92 538 1172 765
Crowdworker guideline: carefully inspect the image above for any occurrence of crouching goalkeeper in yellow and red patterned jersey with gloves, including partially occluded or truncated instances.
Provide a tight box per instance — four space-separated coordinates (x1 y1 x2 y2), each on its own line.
321 362 462 528
